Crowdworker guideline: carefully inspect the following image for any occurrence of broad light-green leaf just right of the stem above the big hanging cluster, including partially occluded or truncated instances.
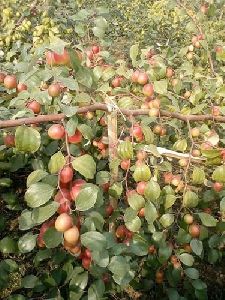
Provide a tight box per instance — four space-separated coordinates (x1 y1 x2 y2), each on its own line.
72 154 96 179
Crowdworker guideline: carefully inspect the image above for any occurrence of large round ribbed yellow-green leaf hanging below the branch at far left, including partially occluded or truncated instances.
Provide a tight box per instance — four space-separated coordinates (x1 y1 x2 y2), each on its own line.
15 126 41 153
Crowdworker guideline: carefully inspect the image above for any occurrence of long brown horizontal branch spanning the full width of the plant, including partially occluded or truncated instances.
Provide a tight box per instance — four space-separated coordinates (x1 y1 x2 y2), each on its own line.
0 104 225 128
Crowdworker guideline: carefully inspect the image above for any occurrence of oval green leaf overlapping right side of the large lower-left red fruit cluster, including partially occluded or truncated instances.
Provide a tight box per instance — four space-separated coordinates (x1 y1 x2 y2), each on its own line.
76 183 99 211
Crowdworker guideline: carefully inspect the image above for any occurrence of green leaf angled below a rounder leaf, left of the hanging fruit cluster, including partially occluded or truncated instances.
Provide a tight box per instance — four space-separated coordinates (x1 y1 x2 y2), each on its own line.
31 201 59 224
